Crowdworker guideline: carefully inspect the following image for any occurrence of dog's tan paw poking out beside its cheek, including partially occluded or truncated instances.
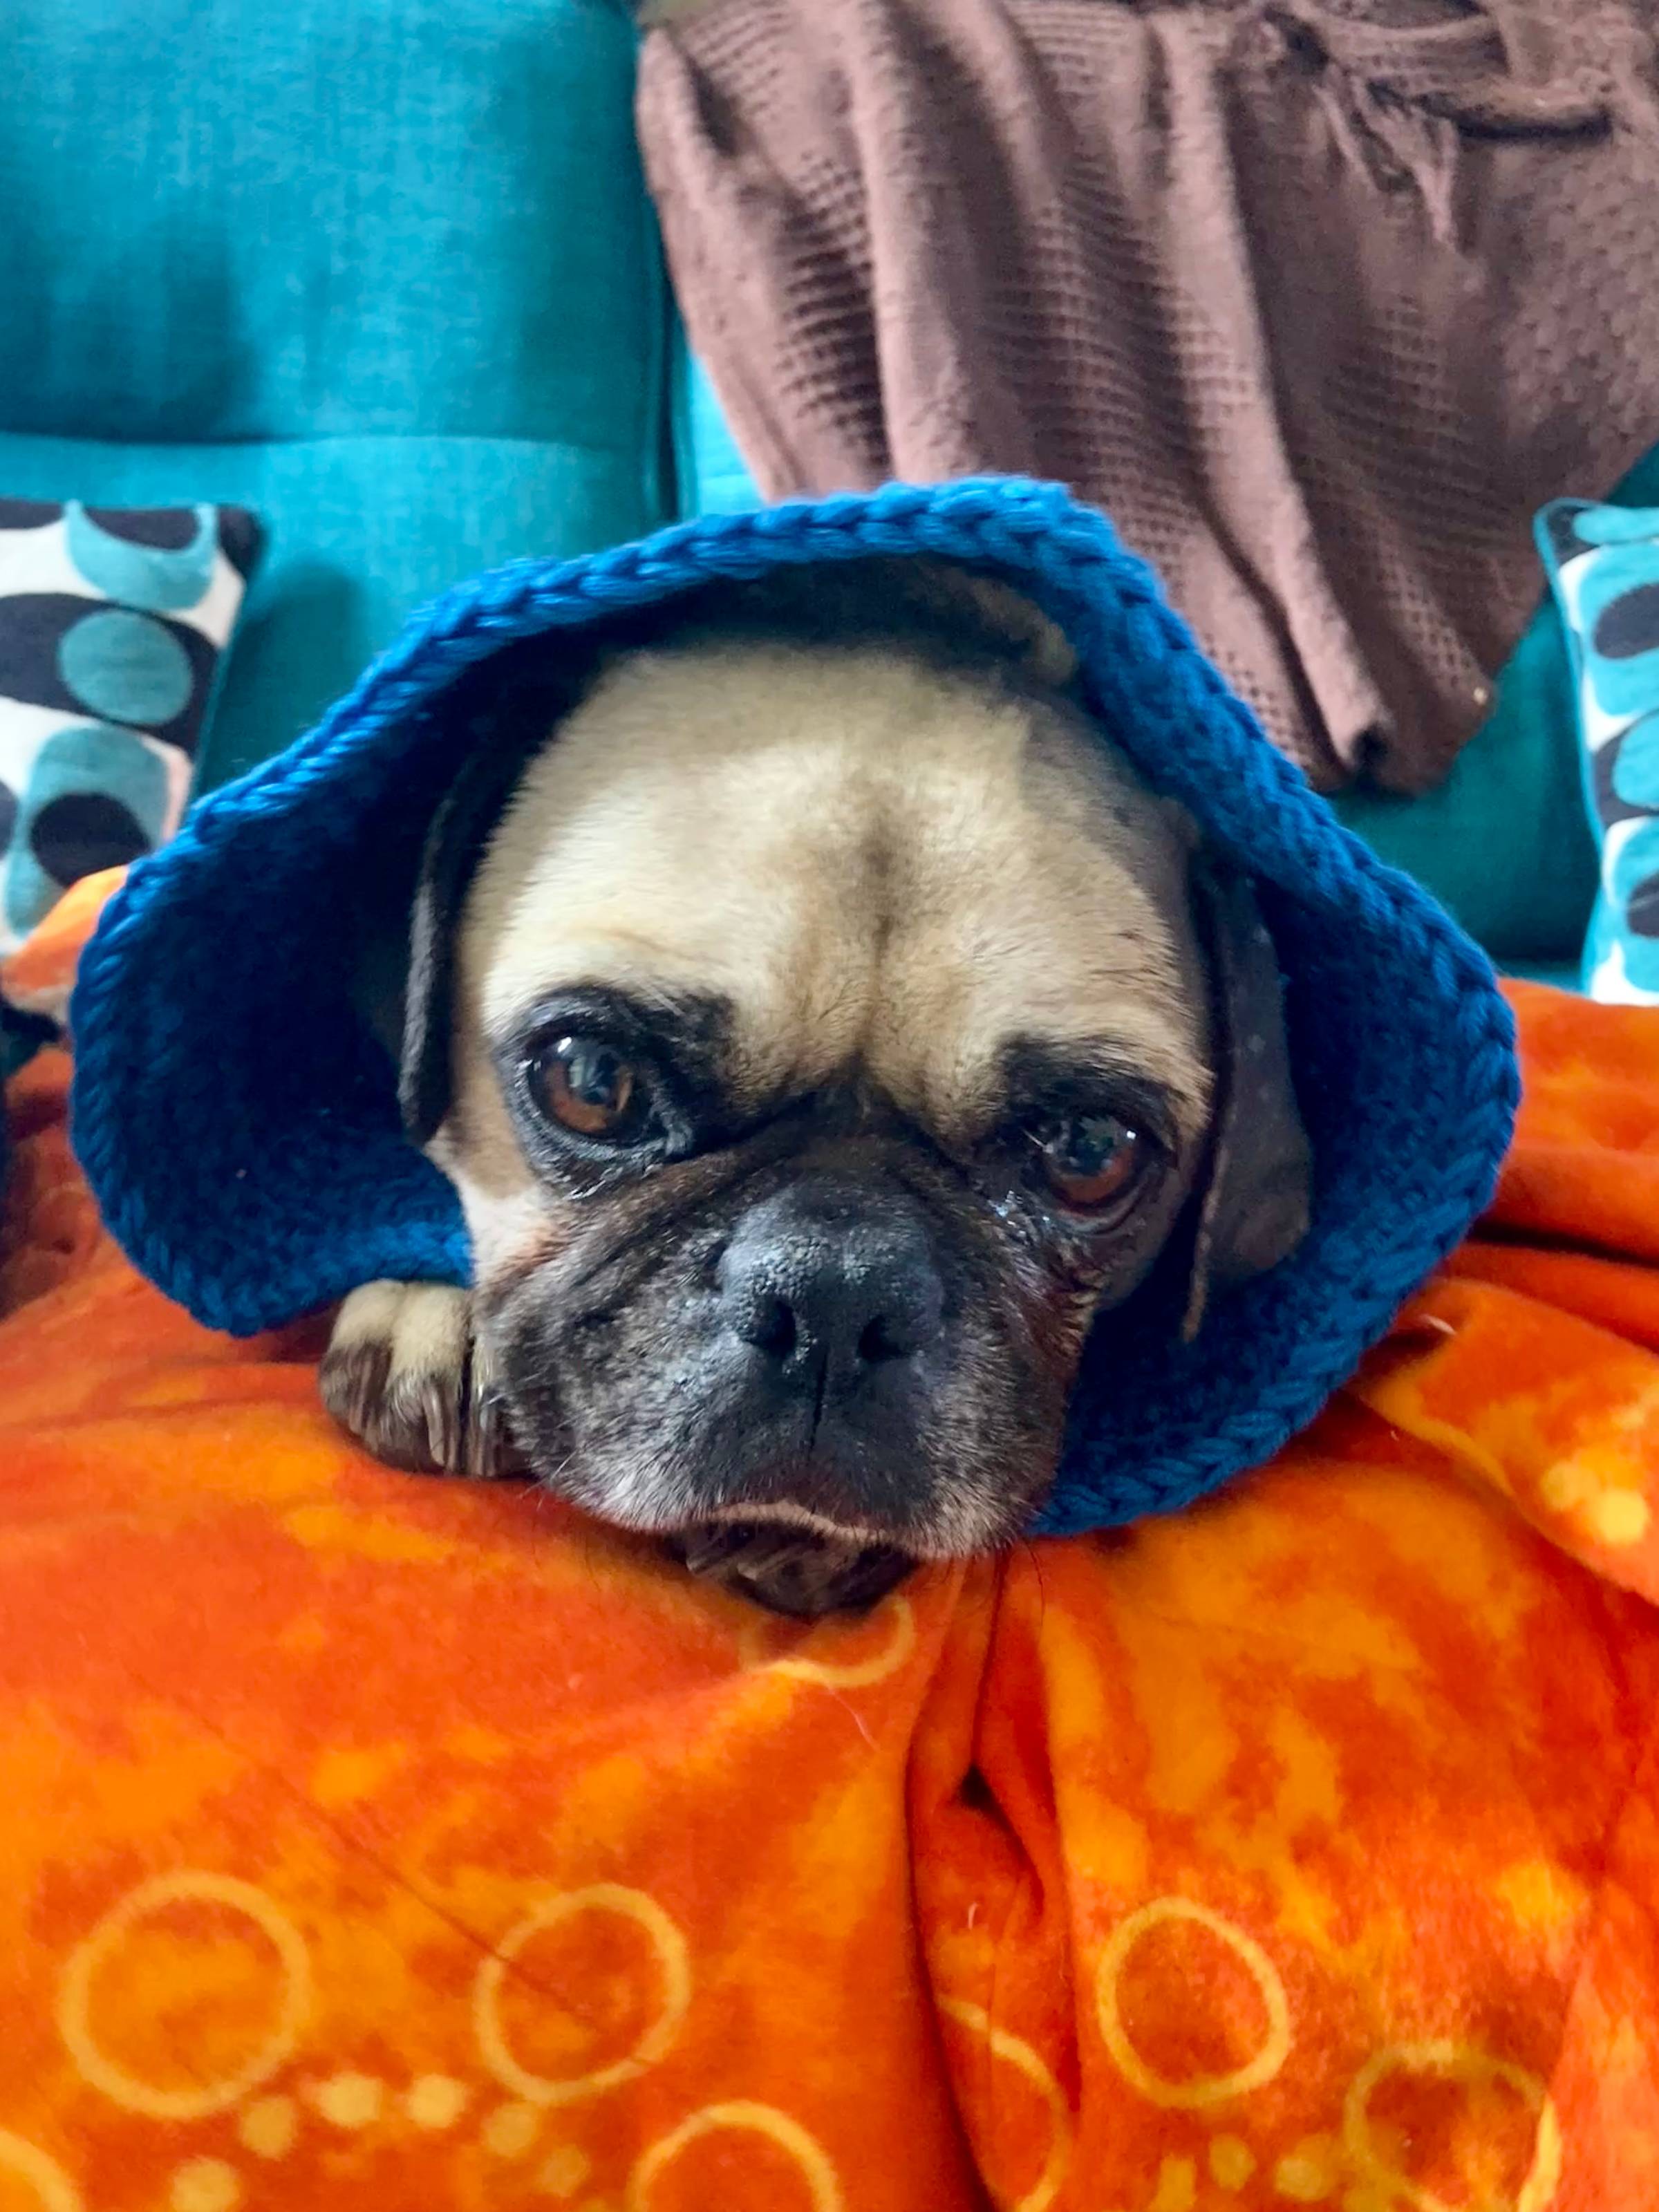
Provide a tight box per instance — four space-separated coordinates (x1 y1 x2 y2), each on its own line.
319 1283 524 1475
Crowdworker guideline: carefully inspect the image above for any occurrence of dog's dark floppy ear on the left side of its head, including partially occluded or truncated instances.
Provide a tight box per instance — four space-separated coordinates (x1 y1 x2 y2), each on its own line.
398 648 593 1143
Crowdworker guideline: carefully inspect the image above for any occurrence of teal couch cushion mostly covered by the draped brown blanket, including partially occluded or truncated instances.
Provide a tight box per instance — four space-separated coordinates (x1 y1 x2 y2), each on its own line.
673 339 1659 980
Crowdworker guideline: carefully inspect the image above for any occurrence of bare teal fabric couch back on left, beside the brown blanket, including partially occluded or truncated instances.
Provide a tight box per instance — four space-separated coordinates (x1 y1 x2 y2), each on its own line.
0 0 668 785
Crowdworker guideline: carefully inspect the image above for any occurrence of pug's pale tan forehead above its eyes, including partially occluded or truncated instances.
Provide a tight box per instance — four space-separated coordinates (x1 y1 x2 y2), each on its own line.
460 644 1208 1130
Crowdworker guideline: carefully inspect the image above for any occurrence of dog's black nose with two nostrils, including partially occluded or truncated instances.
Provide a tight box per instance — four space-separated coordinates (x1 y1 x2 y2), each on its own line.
719 1177 944 1391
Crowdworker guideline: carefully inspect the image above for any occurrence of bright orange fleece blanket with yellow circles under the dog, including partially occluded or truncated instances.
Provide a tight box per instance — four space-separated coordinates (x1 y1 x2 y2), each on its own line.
0 880 1659 2212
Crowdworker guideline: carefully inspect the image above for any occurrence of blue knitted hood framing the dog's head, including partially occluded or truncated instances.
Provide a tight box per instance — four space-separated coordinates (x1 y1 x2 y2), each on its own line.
73 480 1515 1530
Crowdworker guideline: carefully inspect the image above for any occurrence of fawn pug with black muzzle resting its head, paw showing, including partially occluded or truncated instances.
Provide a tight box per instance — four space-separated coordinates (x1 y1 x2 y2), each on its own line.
321 560 1309 1615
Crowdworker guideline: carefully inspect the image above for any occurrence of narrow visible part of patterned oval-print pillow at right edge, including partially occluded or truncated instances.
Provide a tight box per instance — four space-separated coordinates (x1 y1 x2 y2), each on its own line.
1537 500 1659 1006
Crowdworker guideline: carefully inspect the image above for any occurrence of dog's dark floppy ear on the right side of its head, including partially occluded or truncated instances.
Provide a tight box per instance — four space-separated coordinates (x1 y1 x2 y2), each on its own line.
1181 854 1314 1342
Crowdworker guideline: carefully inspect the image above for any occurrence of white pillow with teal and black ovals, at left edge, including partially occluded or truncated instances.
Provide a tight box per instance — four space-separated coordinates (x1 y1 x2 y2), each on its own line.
0 500 259 955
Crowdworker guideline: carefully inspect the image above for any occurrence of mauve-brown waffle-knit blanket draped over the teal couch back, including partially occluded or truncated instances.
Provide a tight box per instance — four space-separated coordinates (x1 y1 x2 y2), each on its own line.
639 0 1659 789
